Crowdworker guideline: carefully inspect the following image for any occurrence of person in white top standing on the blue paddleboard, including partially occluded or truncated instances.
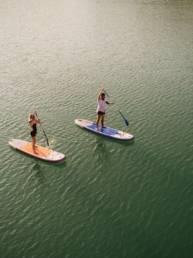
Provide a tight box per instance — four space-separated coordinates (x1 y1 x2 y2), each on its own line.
96 89 114 130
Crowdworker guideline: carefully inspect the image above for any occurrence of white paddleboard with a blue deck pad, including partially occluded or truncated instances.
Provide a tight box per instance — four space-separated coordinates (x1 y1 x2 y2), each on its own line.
74 119 134 141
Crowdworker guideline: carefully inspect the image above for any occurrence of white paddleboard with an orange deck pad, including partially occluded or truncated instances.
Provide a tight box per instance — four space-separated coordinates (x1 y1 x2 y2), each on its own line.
9 139 65 162
